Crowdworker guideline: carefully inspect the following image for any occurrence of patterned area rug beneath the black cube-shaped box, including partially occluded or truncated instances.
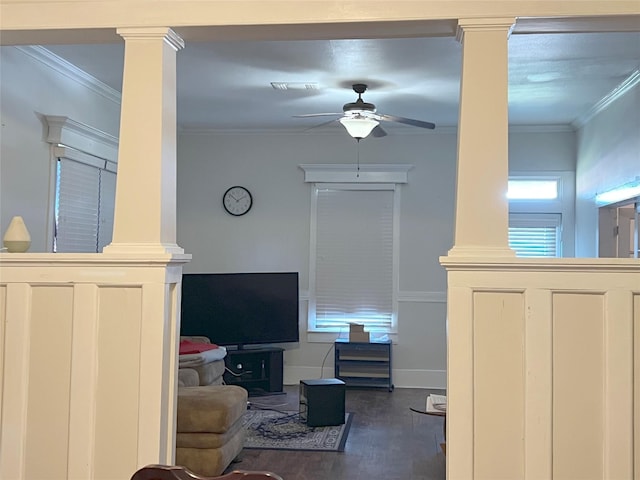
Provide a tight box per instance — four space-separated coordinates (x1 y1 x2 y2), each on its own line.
243 409 353 452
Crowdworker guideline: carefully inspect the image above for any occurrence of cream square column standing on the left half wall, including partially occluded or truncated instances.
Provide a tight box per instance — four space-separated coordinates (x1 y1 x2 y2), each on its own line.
104 27 184 253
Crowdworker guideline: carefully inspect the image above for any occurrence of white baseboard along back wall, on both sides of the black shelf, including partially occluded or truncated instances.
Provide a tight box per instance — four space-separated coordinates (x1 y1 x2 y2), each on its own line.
284 364 447 389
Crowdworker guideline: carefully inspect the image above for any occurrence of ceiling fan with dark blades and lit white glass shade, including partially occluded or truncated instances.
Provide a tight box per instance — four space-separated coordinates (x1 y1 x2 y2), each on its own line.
294 83 436 141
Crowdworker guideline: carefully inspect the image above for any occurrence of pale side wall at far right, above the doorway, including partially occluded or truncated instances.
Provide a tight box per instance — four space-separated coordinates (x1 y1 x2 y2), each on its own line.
576 83 640 257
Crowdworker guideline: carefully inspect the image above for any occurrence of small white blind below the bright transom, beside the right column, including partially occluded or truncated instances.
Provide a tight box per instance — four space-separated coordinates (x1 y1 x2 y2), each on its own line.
509 213 561 257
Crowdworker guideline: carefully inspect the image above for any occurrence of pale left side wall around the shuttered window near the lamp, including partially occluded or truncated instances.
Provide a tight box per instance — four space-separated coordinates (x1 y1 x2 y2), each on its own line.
0 47 120 252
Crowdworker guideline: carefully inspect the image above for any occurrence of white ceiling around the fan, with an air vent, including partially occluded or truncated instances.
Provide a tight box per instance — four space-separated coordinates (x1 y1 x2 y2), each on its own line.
47 32 640 131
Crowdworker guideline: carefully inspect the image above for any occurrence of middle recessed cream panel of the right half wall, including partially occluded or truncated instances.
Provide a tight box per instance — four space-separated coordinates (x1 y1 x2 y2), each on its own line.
552 293 605 478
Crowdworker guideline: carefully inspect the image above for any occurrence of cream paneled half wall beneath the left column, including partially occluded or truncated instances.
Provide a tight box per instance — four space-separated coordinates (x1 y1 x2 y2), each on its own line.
0 254 190 480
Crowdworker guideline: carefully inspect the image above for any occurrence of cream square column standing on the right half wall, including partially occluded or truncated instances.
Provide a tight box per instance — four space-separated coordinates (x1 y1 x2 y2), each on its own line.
449 18 515 257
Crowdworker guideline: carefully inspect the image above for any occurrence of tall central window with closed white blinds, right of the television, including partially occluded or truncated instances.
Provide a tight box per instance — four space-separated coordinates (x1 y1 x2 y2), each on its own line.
309 185 397 332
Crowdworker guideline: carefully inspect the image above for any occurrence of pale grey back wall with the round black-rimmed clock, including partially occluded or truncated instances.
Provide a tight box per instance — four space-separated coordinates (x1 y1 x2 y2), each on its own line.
178 126 575 387
